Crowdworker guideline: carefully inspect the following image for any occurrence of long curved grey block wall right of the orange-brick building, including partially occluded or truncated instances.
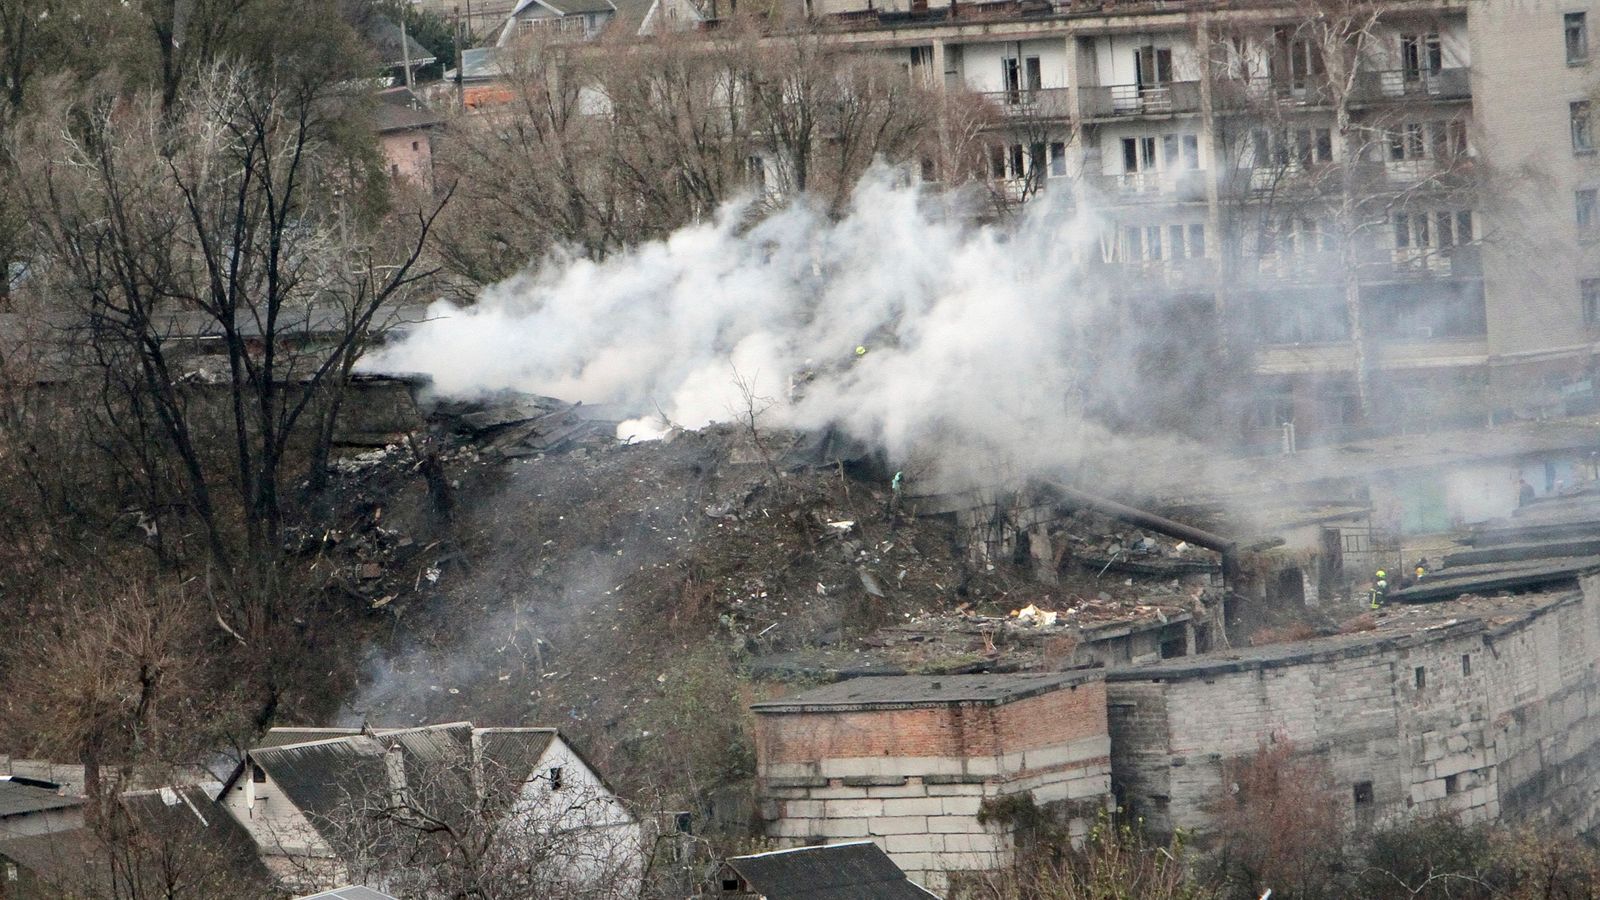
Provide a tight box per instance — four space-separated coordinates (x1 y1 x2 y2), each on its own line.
1107 578 1600 833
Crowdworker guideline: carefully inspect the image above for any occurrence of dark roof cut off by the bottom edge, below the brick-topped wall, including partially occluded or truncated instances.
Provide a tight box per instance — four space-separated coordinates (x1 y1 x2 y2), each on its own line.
728 841 938 900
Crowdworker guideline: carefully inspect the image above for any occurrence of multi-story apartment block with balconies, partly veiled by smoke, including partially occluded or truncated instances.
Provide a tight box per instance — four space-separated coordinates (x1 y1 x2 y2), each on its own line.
810 0 1600 440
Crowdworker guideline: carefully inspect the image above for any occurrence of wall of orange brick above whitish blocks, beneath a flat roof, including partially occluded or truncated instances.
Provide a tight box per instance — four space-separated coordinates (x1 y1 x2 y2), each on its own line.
757 681 1110 890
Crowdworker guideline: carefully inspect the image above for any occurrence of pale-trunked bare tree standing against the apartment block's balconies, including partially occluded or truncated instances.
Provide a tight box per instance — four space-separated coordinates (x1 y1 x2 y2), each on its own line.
1208 0 1482 421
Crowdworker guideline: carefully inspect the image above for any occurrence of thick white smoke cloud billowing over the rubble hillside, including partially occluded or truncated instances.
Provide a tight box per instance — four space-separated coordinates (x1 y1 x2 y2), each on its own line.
371 173 1184 484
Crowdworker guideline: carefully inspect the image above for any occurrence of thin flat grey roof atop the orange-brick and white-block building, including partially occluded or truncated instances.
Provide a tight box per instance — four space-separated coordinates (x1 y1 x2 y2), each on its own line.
750 669 1102 713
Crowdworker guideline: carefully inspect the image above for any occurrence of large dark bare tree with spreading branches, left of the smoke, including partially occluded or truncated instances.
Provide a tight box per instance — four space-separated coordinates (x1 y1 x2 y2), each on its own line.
10 67 451 721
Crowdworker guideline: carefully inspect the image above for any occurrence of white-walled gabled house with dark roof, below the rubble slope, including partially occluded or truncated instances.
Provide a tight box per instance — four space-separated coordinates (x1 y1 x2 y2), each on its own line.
218 722 643 898
